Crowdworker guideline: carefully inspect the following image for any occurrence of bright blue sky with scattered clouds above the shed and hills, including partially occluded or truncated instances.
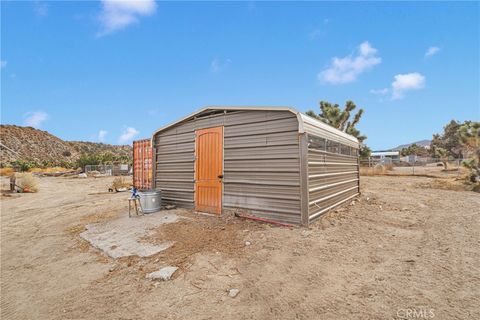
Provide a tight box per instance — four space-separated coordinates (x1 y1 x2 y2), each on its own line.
0 0 480 149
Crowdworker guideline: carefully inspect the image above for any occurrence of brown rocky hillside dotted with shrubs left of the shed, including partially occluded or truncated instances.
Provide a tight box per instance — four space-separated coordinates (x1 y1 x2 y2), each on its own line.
0 125 132 166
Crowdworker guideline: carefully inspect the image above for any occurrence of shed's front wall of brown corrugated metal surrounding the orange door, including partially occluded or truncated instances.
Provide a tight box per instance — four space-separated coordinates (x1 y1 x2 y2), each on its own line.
153 110 301 224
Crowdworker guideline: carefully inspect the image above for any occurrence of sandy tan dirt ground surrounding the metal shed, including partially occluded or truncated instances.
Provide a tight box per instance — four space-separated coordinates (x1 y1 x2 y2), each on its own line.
1 176 480 319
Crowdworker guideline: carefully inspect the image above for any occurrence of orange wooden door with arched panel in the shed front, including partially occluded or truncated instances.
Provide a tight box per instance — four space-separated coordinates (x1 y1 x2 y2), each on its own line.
195 127 223 214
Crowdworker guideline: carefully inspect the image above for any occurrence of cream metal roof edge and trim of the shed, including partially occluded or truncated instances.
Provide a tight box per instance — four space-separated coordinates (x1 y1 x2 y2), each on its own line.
153 106 358 146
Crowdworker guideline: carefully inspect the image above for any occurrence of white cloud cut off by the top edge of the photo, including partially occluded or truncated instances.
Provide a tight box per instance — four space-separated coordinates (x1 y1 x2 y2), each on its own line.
97 0 157 37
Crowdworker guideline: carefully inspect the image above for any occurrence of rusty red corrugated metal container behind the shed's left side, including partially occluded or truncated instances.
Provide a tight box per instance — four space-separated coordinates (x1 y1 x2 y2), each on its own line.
133 139 152 189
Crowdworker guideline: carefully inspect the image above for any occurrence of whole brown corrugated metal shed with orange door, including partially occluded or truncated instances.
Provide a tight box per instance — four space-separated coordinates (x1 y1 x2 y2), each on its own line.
152 106 360 225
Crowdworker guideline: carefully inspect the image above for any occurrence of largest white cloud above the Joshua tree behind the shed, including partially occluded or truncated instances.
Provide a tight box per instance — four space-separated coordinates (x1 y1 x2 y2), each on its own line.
318 41 382 84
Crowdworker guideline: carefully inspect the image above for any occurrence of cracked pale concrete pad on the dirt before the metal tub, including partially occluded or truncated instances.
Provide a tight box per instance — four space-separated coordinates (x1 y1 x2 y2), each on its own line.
80 211 179 259
